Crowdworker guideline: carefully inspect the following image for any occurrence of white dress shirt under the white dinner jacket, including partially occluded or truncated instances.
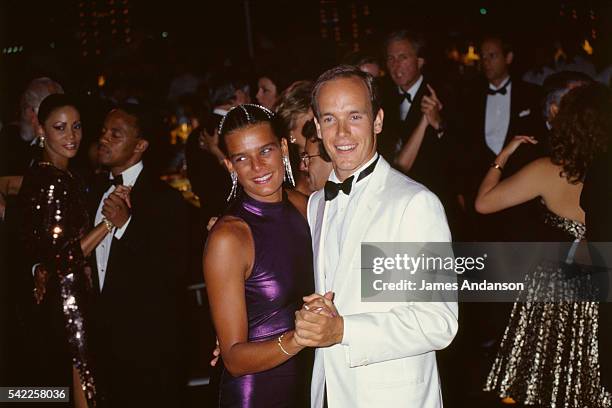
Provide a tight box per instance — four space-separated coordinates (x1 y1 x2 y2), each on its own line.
323 153 378 291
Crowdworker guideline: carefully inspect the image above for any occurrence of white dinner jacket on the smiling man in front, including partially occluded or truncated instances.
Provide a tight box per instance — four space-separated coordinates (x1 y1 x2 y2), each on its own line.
308 157 458 408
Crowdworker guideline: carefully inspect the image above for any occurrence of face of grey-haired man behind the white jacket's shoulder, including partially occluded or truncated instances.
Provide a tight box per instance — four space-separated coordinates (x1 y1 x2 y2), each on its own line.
387 40 425 91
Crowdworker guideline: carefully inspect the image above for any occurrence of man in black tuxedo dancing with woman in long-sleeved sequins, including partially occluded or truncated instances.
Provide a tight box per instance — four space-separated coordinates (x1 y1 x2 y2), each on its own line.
92 104 188 408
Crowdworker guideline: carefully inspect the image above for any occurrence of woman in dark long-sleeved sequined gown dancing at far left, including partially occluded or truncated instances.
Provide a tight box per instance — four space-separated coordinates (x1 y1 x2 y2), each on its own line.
19 94 126 407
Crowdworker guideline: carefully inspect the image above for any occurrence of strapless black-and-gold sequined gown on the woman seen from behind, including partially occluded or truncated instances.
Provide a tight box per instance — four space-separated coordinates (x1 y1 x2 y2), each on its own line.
484 208 612 408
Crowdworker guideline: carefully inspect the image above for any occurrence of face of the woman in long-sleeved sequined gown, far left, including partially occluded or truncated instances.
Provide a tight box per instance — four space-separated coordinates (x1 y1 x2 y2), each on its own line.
39 106 82 161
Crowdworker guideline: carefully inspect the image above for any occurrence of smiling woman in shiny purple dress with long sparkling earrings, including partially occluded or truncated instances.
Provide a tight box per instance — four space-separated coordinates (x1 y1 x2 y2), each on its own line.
203 105 313 408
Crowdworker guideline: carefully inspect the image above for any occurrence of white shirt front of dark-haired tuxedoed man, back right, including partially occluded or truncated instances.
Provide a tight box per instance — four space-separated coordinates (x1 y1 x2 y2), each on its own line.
485 78 512 155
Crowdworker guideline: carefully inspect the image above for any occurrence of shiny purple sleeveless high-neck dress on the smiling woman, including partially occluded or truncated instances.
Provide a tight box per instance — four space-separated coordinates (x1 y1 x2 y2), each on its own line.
219 193 314 408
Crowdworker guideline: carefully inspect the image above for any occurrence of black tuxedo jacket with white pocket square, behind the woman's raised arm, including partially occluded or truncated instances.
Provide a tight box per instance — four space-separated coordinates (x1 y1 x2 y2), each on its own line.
455 79 548 241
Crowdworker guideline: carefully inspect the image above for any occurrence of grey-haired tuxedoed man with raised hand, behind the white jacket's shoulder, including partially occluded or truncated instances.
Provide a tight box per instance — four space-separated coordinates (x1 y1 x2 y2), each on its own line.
378 30 454 214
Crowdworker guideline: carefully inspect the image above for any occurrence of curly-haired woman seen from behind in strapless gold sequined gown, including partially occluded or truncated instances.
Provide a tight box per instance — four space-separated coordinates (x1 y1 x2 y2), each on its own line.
476 84 612 408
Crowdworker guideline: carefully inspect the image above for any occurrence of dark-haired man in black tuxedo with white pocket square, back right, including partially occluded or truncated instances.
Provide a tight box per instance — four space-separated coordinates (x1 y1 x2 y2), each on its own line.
459 37 547 241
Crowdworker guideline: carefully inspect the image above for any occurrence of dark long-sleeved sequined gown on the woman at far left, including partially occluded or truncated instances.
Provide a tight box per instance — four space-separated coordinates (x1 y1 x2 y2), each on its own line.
19 162 99 407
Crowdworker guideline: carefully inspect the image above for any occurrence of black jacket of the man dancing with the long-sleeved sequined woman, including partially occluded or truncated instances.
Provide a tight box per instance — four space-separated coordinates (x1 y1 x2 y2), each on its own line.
91 166 188 408
